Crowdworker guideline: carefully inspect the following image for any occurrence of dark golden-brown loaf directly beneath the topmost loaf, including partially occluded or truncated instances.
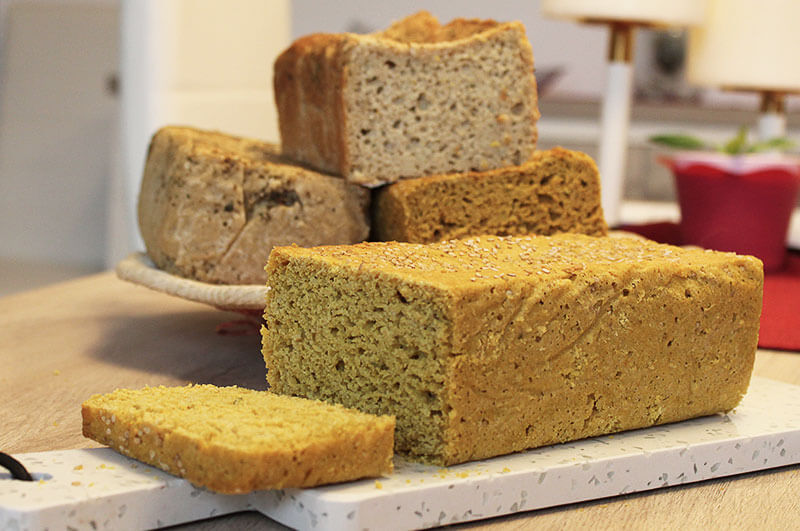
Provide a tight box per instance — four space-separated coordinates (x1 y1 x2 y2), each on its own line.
372 148 607 243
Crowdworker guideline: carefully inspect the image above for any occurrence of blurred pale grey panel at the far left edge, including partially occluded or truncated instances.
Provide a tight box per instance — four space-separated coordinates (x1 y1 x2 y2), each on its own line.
0 1 117 267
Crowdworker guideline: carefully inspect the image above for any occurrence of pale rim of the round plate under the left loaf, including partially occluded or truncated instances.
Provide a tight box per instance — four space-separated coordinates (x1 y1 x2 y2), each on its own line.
116 252 267 314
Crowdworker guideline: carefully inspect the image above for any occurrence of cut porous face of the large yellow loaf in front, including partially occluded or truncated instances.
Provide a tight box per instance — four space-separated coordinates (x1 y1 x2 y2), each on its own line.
263 247 450 457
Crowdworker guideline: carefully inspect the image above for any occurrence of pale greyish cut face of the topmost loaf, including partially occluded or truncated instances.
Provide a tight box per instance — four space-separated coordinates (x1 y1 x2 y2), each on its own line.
344 25 538 186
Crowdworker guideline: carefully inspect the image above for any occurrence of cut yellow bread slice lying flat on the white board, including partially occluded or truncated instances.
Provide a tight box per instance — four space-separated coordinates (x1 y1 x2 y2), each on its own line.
82 385 394 494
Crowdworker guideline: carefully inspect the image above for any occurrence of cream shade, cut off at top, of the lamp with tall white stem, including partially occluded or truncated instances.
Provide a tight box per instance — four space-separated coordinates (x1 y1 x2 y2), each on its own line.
541 0 708 26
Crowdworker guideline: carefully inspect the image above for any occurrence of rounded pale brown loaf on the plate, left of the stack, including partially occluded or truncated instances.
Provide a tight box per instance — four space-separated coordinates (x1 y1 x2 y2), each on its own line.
138 127 369 284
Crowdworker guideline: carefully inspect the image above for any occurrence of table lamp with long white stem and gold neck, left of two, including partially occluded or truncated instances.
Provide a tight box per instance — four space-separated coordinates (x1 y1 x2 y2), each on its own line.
541 0 706 226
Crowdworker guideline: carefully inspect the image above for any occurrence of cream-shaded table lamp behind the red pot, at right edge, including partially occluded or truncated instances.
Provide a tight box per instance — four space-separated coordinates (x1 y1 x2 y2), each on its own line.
687 0 800 140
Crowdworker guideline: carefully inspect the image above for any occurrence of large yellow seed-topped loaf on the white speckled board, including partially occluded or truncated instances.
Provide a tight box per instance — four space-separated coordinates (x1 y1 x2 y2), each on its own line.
263 234 763 465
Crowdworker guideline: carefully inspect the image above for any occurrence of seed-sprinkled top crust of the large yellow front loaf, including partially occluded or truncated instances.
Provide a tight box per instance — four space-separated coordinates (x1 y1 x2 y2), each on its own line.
267 233 763 293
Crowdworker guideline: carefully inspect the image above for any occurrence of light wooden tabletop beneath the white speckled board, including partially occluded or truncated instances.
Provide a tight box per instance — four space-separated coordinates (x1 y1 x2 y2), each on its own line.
0 273 800 529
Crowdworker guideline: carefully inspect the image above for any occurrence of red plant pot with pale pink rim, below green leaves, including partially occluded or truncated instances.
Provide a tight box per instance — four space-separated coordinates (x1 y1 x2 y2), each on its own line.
663 154 800 271
